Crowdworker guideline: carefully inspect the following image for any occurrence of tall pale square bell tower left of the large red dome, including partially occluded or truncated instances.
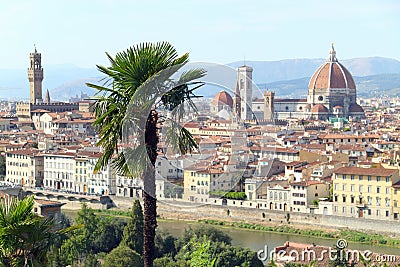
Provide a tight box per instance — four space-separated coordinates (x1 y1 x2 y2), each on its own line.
234 65 253 120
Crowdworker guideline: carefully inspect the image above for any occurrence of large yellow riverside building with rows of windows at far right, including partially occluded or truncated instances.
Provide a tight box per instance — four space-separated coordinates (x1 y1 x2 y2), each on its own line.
332 167 399 220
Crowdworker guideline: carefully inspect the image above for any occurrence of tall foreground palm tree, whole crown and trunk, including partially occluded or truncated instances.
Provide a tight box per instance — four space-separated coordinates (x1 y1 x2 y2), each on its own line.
87 42 205 267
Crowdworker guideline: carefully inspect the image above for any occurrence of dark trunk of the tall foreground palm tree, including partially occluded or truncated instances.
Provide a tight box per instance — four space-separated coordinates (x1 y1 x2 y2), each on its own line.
143 110 159 267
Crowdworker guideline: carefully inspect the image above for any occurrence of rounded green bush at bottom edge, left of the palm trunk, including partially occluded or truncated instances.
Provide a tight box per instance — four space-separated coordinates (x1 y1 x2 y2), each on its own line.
103 245 143 267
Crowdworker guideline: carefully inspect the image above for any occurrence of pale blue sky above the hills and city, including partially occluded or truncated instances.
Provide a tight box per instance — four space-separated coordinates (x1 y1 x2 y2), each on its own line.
0 0 400 69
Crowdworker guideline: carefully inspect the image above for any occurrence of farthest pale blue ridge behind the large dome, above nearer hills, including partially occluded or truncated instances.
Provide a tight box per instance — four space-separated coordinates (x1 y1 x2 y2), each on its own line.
228 57 400 84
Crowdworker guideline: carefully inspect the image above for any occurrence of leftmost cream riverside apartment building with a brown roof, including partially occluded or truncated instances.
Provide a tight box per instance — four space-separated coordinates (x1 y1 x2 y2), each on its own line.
6 149 44 187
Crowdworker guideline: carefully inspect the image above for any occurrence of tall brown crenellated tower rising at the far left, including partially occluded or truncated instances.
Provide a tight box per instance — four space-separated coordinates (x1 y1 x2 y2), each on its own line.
28 47 43 104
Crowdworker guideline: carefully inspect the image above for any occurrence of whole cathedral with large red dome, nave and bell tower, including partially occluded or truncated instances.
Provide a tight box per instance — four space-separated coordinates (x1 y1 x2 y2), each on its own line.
212 44 365 121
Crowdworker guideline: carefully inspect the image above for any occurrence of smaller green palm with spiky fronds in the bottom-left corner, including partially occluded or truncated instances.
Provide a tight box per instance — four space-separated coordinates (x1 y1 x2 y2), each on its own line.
0 196 65 266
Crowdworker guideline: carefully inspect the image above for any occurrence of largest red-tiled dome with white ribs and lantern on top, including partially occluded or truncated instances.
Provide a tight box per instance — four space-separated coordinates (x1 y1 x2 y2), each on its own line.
308 45 356 91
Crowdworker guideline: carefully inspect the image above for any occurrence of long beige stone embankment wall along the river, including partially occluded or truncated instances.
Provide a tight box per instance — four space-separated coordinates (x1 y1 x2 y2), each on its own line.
157 202 400 236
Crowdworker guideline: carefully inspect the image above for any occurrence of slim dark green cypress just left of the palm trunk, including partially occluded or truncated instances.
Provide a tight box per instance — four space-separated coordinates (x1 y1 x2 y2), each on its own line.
122 199 144 254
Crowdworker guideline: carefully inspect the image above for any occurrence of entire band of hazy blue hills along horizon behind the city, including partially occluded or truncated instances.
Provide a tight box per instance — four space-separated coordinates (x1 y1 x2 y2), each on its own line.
0 57 400 100
